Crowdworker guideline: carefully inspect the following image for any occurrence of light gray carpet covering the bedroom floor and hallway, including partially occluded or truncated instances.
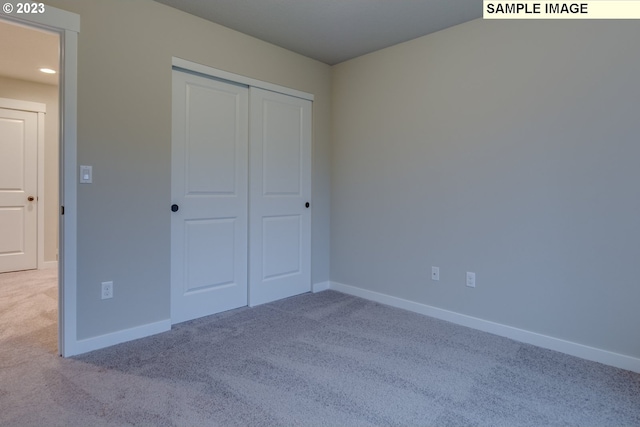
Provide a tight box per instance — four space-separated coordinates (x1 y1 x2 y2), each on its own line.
0 275 640 426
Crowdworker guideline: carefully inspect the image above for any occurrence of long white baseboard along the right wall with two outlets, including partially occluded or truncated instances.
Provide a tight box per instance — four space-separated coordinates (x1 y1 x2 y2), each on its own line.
329 282 640 373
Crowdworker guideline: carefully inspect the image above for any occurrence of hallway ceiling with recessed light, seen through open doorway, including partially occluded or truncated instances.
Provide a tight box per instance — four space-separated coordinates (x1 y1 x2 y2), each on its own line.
0 20 60 85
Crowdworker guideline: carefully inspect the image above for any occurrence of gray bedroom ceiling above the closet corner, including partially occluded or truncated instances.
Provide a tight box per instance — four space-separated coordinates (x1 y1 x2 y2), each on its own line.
156 0 482 65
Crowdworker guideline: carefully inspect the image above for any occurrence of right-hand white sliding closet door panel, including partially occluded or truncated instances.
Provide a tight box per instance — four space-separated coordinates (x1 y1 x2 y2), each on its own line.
249 87 311 306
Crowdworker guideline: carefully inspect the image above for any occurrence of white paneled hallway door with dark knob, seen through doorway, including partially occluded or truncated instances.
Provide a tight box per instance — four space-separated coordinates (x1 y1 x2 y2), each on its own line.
0 108 38 273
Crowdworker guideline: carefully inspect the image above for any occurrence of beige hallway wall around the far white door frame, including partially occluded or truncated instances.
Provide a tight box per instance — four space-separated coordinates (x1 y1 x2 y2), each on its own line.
0 76 59 262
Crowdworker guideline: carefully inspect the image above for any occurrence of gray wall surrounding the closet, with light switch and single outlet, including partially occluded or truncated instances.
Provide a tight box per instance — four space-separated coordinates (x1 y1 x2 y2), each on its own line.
47 0 331 339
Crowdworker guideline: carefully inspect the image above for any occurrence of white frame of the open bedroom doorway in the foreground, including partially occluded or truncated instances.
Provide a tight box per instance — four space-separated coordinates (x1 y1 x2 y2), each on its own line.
0 5 80 357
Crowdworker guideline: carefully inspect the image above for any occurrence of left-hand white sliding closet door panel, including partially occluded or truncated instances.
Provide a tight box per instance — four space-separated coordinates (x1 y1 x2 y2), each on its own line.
167 70 249 323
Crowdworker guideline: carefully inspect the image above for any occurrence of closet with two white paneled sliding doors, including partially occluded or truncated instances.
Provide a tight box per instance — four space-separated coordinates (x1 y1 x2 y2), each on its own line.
170 68 312 324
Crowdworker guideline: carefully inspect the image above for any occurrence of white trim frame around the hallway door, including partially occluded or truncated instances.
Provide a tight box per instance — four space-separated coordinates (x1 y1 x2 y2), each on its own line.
0 98 47 270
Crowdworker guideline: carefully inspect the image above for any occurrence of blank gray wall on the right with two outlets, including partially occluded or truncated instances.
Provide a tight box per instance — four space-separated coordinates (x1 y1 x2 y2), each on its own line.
331 20 640 357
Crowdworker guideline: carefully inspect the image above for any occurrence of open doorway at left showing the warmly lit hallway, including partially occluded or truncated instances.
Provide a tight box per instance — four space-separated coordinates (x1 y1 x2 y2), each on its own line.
0 19 60 353
